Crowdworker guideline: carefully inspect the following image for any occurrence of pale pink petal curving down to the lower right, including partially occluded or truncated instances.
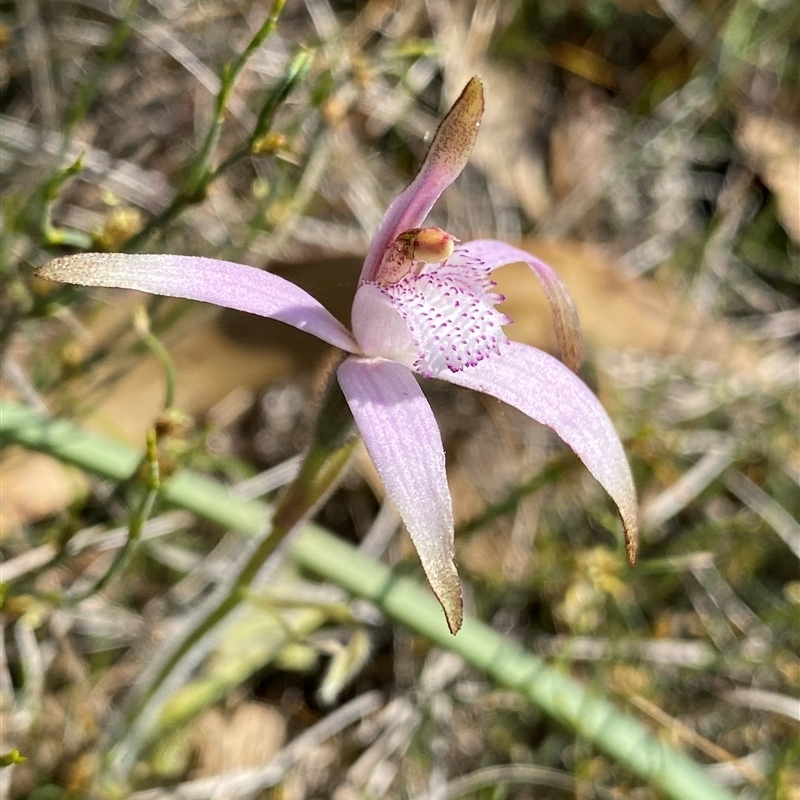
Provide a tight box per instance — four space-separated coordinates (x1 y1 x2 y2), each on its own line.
436 342 638 564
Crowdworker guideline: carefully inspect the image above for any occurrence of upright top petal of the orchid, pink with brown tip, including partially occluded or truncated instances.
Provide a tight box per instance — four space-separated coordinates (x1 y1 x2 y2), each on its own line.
361 78 483 282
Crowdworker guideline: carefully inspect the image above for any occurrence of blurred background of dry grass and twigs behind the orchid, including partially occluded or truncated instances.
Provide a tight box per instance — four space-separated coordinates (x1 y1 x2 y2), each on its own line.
0 0 800 800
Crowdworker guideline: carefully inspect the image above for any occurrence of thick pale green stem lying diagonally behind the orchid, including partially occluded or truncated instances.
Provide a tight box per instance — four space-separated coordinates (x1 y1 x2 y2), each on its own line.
0 403 733 800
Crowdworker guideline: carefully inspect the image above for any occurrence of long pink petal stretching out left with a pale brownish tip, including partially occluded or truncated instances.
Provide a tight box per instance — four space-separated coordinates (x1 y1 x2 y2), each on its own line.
36 253 359 353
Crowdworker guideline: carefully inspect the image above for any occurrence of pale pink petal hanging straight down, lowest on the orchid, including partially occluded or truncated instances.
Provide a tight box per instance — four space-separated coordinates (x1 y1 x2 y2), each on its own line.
338 358 463 633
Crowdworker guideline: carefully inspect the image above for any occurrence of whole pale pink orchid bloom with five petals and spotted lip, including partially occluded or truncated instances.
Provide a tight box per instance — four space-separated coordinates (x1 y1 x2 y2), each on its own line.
38 78 637 633
